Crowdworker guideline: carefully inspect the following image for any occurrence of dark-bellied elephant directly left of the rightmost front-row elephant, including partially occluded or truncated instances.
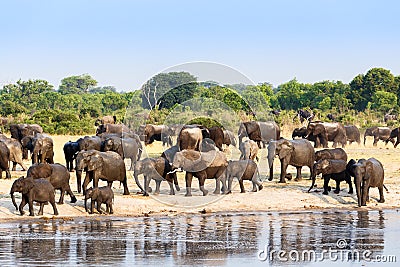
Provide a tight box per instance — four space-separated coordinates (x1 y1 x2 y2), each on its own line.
308 159 353 195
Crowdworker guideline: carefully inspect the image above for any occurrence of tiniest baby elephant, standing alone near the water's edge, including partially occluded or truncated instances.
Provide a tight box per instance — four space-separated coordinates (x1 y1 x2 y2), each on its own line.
85 186 114 214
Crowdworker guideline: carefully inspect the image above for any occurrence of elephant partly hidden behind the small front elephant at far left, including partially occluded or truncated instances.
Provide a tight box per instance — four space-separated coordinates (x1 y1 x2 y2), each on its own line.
26 163 76 204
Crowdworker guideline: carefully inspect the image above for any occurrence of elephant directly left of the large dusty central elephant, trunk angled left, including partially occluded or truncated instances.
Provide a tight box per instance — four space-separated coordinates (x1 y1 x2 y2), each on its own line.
133 157 180 196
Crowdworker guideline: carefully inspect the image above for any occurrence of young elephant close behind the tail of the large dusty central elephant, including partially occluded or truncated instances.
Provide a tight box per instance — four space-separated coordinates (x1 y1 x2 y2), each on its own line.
225 159 263 194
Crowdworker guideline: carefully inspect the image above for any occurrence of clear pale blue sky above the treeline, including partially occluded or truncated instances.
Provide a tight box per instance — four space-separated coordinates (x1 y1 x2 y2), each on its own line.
0 0 400 90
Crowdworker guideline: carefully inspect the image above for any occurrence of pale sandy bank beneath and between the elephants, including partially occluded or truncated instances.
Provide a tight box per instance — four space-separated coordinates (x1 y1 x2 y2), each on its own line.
0 136 400 223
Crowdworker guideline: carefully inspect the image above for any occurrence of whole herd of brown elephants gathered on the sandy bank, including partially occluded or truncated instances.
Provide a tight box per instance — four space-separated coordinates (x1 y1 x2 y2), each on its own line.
0 120 392 216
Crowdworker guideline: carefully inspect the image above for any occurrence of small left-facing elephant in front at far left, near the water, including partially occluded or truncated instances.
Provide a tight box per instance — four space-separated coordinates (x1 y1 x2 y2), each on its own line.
10 177 58 216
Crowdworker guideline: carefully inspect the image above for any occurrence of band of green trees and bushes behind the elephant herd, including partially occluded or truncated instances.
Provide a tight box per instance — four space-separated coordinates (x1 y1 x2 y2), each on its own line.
0 68 400 134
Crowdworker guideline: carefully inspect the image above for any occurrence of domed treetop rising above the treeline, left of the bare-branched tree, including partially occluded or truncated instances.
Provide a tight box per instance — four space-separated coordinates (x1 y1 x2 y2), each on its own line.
58 74 97 95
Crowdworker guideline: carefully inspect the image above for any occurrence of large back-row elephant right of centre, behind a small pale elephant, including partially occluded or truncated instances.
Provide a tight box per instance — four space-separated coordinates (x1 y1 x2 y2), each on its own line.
238 121 280 148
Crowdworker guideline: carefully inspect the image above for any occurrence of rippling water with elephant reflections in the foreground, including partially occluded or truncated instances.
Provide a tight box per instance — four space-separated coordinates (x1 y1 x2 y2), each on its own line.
0 211 400 266
